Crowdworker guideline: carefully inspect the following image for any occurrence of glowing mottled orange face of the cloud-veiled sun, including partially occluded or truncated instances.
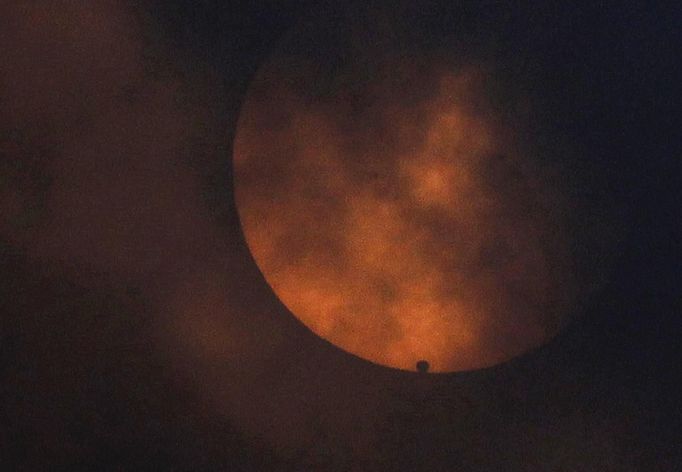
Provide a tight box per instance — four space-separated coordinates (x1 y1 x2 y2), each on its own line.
234 58 574 371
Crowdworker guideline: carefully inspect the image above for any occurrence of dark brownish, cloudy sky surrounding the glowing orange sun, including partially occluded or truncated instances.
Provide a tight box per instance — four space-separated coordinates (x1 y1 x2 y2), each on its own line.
0 0 682 471
